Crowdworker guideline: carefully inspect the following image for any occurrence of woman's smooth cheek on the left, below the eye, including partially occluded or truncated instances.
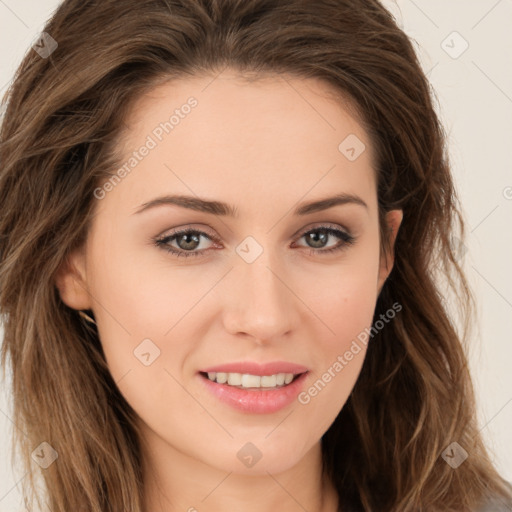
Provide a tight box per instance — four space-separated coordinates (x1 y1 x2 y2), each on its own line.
86 258 194 425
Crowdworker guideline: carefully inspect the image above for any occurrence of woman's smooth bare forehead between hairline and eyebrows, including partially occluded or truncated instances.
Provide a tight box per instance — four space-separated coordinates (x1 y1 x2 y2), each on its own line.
102 72 375 216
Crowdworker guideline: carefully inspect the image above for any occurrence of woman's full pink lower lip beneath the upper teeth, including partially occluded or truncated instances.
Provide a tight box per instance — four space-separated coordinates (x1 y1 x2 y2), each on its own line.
199 372 308 414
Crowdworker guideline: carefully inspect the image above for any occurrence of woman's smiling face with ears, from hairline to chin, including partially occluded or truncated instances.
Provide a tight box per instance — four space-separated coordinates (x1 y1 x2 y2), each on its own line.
58 73 401 474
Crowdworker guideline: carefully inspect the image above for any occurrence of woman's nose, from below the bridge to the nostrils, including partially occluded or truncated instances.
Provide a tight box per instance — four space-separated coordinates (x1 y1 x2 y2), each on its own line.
223 251 301 344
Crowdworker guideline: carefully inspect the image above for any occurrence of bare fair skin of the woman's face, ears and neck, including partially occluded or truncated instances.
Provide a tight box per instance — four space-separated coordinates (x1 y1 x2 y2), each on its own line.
57 71 402 512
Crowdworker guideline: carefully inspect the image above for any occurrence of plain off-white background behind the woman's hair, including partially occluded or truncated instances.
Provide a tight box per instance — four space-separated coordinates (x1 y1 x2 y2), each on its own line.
0 0 512 512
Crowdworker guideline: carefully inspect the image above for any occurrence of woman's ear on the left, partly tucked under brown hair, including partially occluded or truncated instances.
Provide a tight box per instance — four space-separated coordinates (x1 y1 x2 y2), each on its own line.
55 246 92 310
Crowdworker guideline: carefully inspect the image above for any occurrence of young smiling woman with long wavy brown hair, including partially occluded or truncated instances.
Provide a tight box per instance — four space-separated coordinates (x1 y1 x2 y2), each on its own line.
0 0 511 512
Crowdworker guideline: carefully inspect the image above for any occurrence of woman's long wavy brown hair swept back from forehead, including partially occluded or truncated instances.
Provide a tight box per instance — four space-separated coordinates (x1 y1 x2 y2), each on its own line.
0 0 510 512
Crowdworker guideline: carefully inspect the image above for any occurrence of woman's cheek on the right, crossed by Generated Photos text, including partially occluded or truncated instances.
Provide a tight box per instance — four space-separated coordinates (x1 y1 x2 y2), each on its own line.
298 246 378 416
